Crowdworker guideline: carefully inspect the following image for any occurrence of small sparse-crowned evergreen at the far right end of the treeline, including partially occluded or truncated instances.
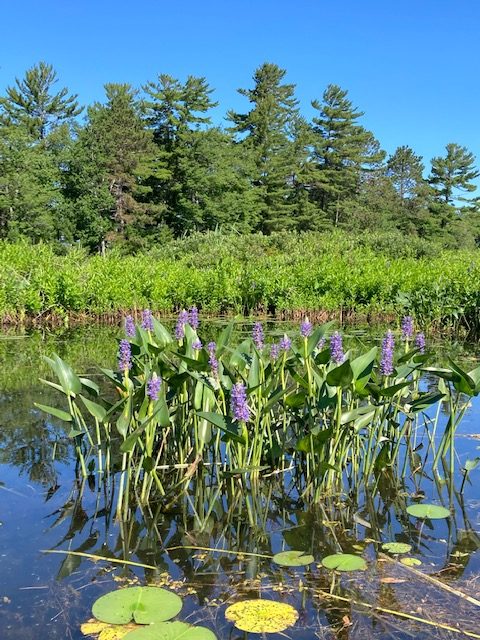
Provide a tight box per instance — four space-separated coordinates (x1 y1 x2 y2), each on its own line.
429 142 480 205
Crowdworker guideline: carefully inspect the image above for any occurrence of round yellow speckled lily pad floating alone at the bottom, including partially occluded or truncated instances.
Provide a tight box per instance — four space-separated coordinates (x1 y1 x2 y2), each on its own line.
225 599 298 633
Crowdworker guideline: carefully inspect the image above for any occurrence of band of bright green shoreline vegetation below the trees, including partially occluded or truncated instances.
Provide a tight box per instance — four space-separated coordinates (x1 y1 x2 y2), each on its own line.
0 231 480 333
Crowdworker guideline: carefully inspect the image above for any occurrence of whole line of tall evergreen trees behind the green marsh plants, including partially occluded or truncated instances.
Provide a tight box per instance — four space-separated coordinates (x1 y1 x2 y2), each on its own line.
0 62 480 252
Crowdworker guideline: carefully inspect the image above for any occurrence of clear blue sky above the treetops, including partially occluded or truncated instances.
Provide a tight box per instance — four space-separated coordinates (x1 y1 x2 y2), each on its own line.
0 0 480 175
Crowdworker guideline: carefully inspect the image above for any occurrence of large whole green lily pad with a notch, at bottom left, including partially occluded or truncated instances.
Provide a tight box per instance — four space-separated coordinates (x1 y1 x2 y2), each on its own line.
92 587 182 624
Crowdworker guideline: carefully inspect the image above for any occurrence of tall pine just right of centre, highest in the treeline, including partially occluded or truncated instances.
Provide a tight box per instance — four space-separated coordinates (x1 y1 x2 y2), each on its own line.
227 63 299 233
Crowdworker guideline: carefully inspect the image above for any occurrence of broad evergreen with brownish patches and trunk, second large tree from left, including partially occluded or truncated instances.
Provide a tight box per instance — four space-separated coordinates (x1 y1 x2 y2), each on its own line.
66 84 162 246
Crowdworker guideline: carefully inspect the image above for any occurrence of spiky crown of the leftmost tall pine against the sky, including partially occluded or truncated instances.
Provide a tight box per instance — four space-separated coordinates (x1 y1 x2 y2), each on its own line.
0 62 82 140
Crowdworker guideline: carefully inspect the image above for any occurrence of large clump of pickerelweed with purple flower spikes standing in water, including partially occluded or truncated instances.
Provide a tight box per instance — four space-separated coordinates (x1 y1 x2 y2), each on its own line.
37 308 480 515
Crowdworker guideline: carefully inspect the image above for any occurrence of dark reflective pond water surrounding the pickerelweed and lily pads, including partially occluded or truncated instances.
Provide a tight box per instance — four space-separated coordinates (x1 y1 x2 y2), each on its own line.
0 327 480 640
